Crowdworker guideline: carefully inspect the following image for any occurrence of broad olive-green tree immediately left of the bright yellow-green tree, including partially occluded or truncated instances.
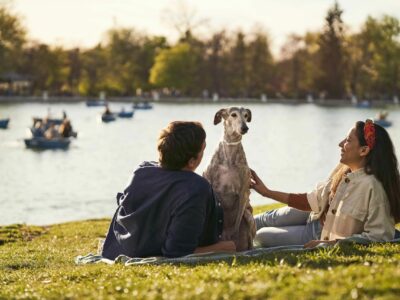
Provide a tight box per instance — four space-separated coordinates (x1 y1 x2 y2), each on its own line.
77 28 166 96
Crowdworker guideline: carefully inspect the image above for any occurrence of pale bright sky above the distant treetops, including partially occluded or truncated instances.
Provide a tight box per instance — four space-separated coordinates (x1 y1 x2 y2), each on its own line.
6 0 400 54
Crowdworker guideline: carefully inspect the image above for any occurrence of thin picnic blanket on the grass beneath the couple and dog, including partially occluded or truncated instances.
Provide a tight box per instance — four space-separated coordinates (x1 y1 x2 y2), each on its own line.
75 236 400 266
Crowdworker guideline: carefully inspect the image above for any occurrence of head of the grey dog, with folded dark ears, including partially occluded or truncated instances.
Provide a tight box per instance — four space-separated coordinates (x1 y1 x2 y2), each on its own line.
214 106 251 135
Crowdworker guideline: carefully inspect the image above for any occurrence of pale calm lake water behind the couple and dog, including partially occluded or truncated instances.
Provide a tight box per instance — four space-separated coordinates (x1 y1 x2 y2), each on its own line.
0 103 400 224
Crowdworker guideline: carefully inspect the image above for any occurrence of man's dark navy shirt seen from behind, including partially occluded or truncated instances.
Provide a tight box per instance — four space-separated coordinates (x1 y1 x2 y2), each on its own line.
102 162 222 259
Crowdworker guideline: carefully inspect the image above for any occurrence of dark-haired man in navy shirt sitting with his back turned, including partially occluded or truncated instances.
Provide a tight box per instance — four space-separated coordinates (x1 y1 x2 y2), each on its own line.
102 122 236 259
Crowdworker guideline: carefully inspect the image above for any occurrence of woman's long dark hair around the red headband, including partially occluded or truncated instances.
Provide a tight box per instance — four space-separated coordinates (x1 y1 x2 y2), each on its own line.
356 121 400 223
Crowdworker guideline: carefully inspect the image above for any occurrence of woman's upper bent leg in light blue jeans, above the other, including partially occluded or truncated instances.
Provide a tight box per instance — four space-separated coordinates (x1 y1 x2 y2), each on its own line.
254 206 310 230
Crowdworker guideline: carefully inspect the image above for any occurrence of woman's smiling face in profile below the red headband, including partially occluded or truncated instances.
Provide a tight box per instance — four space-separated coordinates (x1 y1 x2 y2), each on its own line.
339 127 365 171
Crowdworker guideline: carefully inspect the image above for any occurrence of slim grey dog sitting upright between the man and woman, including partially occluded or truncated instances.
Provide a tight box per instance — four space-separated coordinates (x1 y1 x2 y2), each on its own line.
203 107 256 251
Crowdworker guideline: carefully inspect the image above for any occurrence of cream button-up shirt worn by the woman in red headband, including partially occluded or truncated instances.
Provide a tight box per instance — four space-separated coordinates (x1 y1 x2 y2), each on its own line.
307 169 395 242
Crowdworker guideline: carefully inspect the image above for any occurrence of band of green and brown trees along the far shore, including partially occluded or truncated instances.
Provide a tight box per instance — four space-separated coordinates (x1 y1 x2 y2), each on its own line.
0 2 400 100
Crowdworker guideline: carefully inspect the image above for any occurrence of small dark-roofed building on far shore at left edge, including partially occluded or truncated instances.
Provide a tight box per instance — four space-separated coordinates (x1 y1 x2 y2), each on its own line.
0 72 32 96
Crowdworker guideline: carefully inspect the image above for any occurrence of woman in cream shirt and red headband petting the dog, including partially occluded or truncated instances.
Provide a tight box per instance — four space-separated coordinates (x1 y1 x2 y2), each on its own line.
251 120 400 247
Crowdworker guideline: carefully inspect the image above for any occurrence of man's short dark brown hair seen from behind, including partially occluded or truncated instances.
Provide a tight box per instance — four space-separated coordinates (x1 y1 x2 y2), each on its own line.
157 121 206 170
